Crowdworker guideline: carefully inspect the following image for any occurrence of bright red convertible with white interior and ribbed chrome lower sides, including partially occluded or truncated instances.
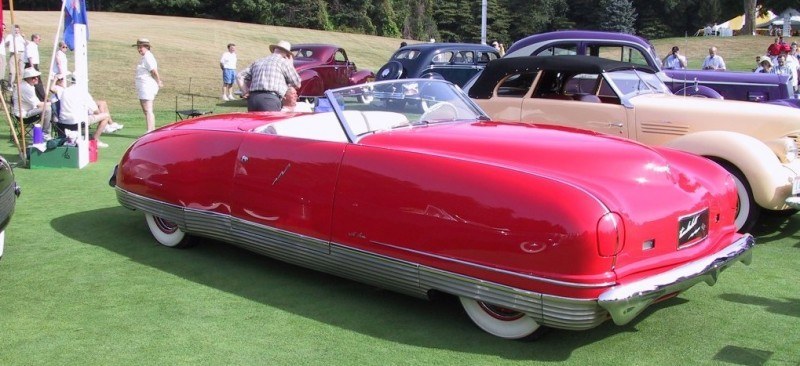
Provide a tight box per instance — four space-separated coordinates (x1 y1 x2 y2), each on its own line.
110 79 754 339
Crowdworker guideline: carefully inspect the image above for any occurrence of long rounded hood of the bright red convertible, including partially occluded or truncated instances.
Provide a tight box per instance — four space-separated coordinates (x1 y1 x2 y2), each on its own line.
360 122 718 212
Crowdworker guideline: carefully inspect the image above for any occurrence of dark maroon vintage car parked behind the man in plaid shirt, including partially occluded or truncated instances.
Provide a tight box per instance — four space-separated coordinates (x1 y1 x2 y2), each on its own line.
292 44 375 97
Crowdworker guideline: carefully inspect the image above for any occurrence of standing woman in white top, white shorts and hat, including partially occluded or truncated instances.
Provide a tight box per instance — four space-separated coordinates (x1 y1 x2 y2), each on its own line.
134 38 164 132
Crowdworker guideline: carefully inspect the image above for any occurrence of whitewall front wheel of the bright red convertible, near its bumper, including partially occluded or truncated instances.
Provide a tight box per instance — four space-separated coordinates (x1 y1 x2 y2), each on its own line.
459 297 545 339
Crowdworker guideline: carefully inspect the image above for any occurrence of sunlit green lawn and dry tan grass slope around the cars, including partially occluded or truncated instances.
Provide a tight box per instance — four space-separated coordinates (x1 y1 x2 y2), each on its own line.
0 12 800 365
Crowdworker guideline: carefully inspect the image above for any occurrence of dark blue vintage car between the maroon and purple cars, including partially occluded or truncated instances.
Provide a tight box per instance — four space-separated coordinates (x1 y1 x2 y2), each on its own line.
375 43 500 86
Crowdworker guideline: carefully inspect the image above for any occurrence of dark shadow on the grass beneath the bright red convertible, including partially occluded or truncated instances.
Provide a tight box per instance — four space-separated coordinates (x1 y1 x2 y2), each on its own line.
51 207 700 361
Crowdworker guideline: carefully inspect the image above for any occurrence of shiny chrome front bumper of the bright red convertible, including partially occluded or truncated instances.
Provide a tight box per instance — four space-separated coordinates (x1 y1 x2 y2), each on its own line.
597 234 755 325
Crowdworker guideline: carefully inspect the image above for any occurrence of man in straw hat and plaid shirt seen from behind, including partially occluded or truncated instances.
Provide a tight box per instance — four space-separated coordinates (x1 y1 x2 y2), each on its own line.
237 41 300 112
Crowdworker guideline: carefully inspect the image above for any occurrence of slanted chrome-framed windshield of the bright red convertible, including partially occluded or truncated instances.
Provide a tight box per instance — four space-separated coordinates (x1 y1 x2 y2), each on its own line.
320 79 488 141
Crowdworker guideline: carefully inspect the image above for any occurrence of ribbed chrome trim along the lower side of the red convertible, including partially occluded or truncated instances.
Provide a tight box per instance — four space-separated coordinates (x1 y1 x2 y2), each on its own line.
115 186 753 330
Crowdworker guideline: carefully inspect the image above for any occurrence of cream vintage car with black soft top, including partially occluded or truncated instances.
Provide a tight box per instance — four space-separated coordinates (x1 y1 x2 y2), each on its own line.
466 56 800 231
